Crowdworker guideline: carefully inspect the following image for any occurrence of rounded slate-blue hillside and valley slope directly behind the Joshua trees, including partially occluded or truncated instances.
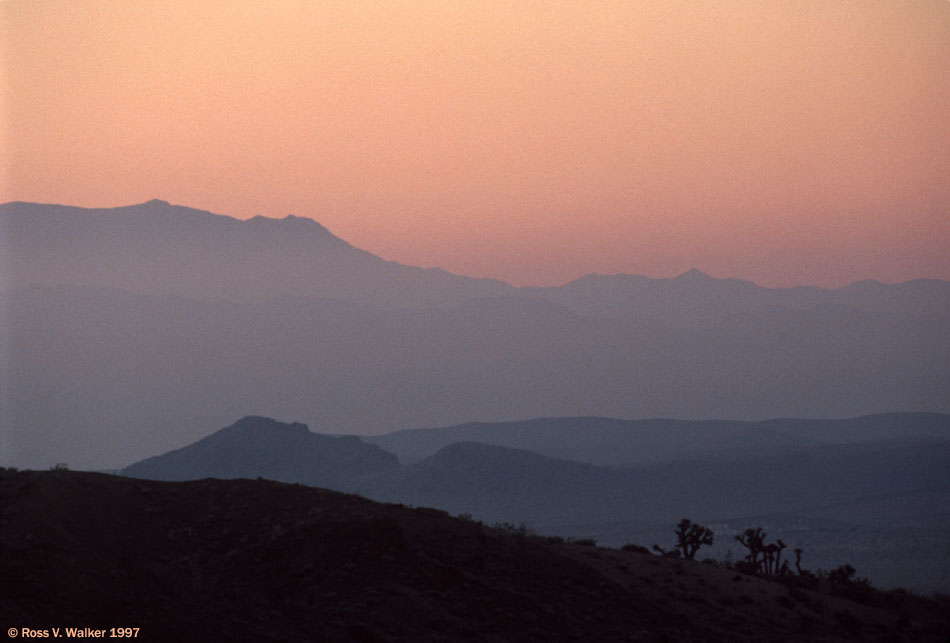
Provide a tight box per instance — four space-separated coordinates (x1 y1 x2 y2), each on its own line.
355 440 950 591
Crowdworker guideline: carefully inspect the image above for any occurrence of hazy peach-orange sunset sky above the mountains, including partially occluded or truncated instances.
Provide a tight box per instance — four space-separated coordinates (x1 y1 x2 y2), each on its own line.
0 0 950 286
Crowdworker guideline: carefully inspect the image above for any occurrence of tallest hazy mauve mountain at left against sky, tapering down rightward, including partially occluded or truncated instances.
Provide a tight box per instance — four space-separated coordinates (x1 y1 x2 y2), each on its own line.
0 199 512 307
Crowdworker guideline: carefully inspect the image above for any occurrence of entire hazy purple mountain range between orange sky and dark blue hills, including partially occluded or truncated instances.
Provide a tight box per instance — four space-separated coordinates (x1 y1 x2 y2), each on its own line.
0 200 950 468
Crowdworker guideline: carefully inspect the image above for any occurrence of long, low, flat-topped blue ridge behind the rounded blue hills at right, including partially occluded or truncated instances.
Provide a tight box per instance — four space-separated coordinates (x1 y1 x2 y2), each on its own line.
363 413 950 467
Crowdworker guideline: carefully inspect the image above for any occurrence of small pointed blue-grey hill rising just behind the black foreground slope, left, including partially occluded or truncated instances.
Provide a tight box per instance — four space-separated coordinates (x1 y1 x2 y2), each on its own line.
122 416 399 489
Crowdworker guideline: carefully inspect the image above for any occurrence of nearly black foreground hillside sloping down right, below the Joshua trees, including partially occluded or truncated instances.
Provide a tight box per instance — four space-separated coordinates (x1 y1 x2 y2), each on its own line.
0 471 950 642
